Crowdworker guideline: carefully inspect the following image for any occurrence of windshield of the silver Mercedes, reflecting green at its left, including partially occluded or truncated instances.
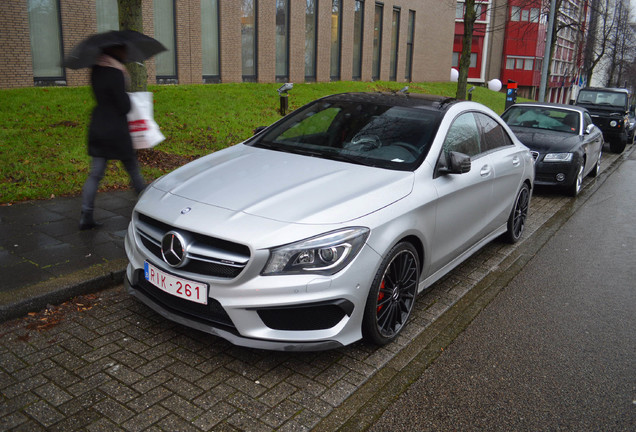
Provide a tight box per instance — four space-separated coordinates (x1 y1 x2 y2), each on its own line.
250 100 440 170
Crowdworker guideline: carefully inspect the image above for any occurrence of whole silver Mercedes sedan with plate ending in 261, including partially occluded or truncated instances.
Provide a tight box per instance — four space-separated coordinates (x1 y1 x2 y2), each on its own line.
126 93 534 350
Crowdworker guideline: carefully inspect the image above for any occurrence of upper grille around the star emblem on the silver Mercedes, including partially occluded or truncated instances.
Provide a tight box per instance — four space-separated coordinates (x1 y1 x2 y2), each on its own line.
135 213 250 279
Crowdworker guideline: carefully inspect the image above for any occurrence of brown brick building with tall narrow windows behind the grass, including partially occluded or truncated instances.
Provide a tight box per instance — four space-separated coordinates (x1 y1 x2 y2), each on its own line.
0 0 454 88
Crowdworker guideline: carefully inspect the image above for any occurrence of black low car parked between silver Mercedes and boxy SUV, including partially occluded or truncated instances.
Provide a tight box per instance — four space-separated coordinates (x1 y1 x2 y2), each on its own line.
501 102 604 196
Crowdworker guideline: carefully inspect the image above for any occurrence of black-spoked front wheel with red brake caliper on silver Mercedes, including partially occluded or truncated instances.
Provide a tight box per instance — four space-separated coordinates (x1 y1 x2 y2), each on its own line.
362 242 420 345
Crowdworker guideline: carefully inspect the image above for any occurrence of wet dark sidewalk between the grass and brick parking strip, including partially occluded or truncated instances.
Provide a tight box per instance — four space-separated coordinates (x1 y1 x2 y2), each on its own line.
0 190 136 322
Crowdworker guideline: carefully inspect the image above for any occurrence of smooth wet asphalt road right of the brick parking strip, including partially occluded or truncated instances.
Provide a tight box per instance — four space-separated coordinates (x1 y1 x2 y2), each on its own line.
371 155 636 431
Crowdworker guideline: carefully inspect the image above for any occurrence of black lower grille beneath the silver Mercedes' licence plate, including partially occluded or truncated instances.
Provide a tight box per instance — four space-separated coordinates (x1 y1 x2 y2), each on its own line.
133 270 236 331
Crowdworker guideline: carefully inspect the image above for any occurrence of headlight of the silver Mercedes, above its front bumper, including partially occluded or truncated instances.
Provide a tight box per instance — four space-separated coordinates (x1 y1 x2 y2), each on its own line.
262 227 369 276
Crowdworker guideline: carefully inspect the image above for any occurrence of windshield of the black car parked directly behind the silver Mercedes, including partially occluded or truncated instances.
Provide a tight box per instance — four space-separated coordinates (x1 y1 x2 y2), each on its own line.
501 105 581 134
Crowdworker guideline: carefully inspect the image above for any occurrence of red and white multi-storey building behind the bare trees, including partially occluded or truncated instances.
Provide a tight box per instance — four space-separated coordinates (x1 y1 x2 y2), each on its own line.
453 0 589 103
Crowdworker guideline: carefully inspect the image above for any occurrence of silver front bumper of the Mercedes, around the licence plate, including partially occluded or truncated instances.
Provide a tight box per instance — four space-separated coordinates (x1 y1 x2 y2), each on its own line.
125 224 380 351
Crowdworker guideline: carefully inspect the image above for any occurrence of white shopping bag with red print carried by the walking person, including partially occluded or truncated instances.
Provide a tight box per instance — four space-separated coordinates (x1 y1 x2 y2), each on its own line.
128 92 166 149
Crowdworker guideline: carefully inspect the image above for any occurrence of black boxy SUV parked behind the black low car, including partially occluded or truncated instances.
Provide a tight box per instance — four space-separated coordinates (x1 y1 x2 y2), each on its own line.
575 87 630 153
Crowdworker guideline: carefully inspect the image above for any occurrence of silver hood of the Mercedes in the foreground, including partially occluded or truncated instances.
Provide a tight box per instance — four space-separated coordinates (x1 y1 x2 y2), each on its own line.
153 144 414 224
